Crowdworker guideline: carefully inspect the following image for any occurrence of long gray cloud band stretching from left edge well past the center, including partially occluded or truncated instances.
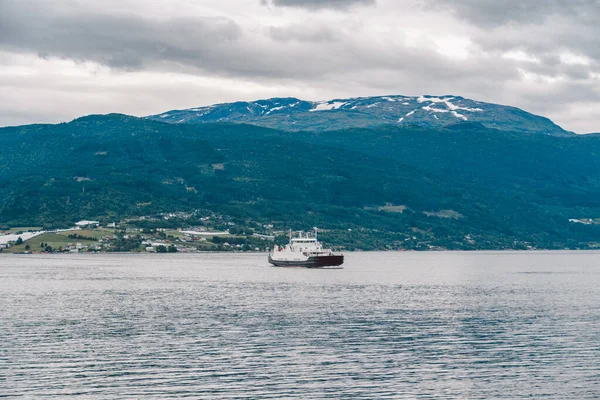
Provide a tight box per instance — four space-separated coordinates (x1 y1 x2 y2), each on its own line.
0 0 476 80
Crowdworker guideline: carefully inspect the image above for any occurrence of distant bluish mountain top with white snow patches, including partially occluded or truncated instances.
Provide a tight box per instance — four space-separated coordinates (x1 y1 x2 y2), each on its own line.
148 96 570 135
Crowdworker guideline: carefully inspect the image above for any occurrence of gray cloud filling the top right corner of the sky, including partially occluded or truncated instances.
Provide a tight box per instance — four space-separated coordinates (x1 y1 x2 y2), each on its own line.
432 0 600 66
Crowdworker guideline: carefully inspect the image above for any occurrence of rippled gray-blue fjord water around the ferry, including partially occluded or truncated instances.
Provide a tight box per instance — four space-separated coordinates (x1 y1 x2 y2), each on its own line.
0 252 600 399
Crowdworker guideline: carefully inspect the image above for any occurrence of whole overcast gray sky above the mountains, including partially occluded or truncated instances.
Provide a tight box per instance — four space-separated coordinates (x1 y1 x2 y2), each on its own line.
0 0 600 133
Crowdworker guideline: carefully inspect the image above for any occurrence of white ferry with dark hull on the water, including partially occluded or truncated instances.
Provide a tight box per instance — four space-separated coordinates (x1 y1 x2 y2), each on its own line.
269 229 344 268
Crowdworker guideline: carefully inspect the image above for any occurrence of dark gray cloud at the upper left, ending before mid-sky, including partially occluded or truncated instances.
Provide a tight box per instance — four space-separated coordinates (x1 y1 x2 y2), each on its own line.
0 0 242 69
